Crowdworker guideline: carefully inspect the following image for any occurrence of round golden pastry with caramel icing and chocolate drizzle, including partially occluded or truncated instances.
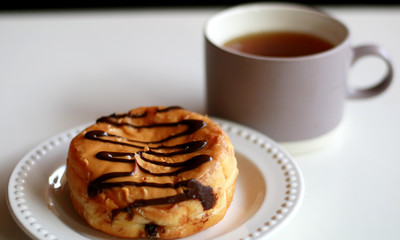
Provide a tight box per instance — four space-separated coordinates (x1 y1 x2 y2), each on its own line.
67 107 238 239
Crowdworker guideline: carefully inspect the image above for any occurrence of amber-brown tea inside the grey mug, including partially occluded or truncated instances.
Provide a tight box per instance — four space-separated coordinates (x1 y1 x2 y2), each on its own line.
224 32 334 57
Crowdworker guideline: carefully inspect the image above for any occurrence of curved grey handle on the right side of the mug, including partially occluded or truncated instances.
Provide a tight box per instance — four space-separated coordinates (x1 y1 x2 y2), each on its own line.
347 45 393 99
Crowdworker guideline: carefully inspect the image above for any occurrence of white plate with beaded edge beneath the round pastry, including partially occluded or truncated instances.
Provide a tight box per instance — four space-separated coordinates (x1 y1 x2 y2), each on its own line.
8 118 304 240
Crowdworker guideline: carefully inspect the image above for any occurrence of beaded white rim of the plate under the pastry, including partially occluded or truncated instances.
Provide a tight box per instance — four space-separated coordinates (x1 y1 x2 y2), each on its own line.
6 117 304 240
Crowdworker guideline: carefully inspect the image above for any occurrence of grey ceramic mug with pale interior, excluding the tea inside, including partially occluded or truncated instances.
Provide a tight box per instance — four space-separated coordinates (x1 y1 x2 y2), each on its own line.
204 3 393 151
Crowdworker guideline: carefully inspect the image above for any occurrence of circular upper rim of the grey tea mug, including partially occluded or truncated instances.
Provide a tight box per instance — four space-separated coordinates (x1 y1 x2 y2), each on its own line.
203 2 350 61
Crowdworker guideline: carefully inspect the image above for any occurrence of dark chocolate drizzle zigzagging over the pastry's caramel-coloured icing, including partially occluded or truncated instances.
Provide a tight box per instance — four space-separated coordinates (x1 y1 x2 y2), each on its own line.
85 107 216 221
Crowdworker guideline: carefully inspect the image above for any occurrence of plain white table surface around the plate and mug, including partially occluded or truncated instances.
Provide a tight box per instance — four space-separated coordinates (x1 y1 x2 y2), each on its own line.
0 6 400 240
